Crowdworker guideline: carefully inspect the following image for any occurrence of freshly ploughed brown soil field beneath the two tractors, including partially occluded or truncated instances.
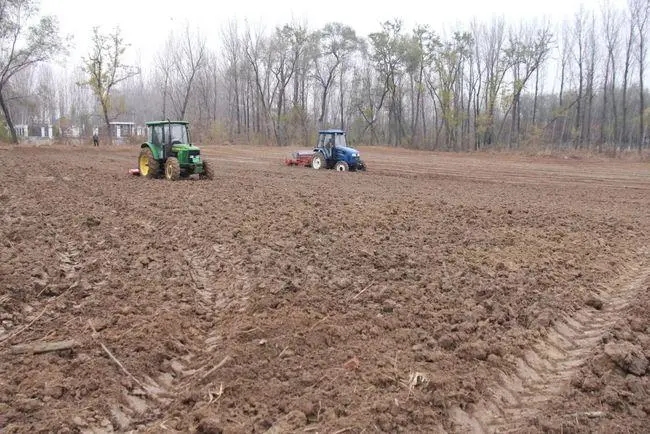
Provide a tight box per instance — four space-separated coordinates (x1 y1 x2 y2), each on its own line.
0 146 650 433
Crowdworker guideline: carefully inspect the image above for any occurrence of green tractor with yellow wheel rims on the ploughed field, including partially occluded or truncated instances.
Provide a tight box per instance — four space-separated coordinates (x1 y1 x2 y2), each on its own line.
138 120 214 181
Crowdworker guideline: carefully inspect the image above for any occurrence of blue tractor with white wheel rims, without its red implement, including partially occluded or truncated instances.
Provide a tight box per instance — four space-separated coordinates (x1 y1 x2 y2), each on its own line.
311 130 366 172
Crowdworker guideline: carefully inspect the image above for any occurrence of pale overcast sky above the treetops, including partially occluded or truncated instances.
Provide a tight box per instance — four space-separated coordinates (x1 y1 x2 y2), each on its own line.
41 0 626 64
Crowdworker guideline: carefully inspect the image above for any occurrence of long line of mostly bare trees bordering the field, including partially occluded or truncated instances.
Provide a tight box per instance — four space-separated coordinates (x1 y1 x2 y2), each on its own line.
0 0 650 151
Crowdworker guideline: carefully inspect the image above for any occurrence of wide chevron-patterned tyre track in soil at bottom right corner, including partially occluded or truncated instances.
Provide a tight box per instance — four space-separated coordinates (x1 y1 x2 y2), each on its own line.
449 258 650 434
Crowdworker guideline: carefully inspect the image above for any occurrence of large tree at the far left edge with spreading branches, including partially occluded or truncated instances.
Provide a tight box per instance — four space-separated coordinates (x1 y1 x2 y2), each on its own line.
0 0 65 143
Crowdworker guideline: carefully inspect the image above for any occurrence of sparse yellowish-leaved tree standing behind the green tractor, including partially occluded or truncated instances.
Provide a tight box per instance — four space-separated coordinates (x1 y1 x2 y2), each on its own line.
81 27 140 145
